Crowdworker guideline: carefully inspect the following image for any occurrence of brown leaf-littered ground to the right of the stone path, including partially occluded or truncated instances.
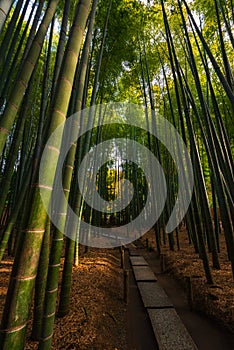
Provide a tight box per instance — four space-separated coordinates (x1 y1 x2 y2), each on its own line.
140 229 234 333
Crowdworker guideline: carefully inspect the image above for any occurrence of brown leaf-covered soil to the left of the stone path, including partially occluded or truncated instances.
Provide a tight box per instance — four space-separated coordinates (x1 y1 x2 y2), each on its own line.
0 249 127 350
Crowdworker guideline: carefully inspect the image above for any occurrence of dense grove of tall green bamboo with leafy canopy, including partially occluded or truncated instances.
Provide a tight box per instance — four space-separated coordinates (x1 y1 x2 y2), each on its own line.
0 0 234 349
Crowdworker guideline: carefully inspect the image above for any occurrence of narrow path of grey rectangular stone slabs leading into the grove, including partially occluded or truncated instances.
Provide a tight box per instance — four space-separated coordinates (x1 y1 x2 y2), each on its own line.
129 248 197 350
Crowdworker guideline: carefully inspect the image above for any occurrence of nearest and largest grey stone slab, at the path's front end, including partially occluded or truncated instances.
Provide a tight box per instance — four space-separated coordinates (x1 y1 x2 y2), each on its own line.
148 309 198 350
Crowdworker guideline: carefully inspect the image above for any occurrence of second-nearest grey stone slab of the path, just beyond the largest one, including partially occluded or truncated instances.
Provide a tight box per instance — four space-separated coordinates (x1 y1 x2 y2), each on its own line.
137 282 173 308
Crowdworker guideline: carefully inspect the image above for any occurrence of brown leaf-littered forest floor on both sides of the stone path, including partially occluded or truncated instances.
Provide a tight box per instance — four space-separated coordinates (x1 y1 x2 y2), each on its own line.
0 230 234 350
